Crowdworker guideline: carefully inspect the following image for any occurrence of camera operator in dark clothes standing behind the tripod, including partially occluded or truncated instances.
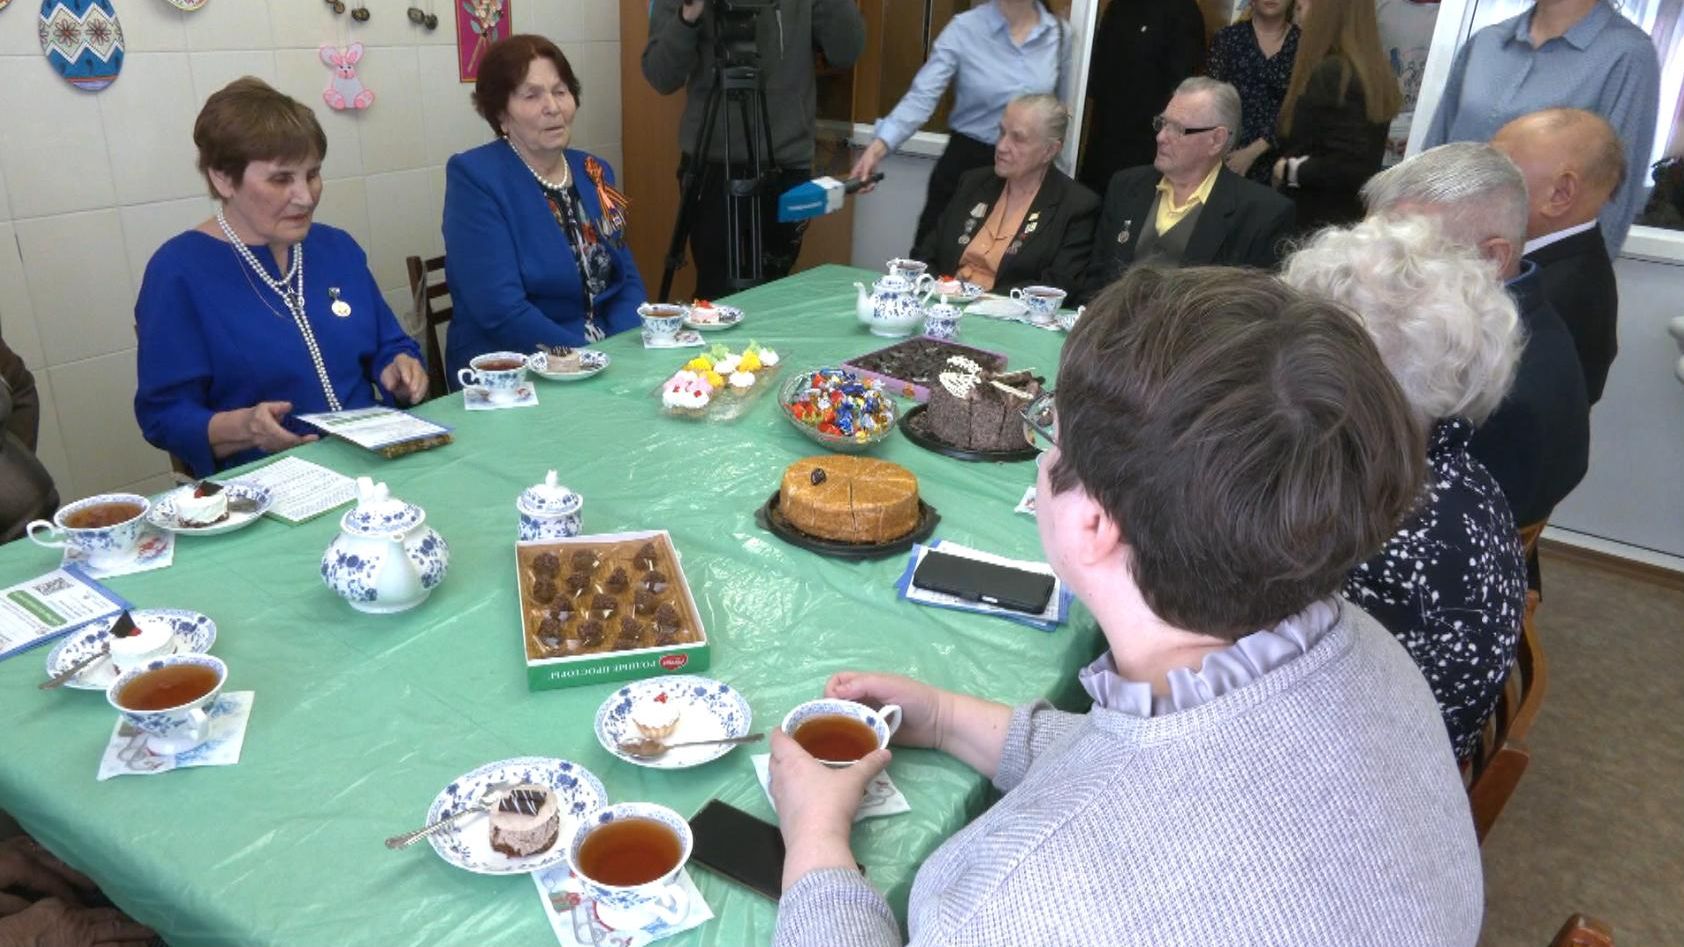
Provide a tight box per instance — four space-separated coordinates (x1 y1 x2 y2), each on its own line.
643 0 866 298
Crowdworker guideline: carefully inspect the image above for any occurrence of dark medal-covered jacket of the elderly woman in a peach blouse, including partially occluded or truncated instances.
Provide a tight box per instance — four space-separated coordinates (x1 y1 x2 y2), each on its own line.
913 165 1100 295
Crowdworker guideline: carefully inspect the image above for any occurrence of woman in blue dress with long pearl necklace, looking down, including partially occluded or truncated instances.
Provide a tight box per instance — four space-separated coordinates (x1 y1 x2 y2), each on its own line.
135 76 426 477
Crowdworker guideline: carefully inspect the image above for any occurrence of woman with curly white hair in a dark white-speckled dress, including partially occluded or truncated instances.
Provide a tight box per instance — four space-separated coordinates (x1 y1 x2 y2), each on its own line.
1283 217 1526 758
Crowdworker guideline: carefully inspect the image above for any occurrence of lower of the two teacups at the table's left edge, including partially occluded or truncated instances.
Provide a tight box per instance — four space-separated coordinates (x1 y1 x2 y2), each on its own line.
106 654 227 753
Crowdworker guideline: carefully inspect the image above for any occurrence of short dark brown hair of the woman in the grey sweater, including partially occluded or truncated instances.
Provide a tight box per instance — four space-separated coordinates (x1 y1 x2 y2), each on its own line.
1047 266 1426 640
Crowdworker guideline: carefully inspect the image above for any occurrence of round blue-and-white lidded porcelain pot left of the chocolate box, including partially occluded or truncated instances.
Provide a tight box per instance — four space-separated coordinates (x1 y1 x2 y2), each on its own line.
322 477 450 613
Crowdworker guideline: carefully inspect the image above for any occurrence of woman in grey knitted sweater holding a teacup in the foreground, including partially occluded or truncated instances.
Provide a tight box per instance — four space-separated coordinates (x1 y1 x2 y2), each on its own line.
771 268 1484 947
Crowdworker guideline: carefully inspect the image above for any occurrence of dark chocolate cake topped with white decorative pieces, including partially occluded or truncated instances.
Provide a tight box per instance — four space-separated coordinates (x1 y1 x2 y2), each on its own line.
919 357 1041 450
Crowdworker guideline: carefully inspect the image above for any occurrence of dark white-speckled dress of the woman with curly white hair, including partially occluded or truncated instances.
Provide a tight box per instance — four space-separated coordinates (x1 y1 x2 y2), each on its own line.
1346 418 1526 758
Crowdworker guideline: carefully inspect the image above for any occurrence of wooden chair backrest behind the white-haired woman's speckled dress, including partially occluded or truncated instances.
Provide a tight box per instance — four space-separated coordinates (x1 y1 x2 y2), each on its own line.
1468 596 1549 843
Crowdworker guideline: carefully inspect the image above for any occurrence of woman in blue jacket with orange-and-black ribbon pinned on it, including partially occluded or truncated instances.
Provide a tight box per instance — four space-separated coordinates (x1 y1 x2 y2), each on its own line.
445 35 643 377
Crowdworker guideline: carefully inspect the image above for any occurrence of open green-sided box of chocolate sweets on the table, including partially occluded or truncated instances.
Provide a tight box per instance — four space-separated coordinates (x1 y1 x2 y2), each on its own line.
515 531 707 689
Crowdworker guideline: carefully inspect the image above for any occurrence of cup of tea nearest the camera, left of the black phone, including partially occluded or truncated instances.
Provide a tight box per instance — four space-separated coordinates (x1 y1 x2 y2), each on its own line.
568 802 695 928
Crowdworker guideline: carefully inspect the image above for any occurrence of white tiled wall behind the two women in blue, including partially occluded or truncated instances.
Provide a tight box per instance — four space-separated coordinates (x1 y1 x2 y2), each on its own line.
0 0 620 500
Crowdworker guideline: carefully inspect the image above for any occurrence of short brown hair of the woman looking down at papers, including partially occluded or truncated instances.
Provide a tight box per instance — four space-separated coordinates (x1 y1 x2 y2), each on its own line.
194 76 327 199
